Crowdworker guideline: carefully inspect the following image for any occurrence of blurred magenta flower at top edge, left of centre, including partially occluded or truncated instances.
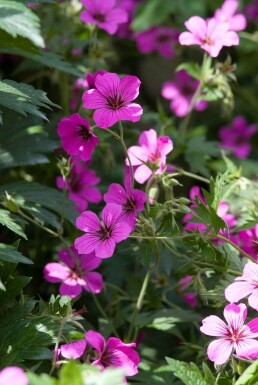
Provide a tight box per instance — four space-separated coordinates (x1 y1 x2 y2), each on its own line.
80 0 128 35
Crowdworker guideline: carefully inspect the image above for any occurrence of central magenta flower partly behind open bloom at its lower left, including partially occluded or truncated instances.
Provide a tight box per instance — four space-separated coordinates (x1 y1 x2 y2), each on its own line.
104 176 146 230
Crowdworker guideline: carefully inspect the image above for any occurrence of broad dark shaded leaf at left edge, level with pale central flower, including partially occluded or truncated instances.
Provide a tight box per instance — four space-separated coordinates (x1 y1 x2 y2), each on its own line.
0 122 57 169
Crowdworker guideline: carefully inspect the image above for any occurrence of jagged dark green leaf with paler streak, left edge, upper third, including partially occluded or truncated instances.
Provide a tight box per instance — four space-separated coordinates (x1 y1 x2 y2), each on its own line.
0 80 58 120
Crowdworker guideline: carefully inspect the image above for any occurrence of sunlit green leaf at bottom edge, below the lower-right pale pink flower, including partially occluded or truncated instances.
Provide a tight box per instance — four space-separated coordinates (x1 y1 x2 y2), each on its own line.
166 357 211 385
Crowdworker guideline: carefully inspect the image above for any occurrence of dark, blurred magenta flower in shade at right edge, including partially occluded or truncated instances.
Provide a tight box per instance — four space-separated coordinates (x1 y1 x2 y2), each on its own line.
219 116 257 159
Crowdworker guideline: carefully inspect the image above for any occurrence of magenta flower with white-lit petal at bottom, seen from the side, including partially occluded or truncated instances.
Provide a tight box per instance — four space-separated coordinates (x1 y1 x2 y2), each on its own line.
86 330 140 376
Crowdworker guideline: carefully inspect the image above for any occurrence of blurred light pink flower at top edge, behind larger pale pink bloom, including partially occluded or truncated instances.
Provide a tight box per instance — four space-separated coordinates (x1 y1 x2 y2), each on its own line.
214 0 246 31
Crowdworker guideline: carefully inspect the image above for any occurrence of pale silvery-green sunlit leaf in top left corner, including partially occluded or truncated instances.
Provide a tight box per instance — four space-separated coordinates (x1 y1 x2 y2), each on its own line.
0 0 45 48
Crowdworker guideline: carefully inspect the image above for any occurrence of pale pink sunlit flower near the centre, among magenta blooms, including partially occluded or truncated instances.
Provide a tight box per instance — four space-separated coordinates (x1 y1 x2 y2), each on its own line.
126 128 173 183
